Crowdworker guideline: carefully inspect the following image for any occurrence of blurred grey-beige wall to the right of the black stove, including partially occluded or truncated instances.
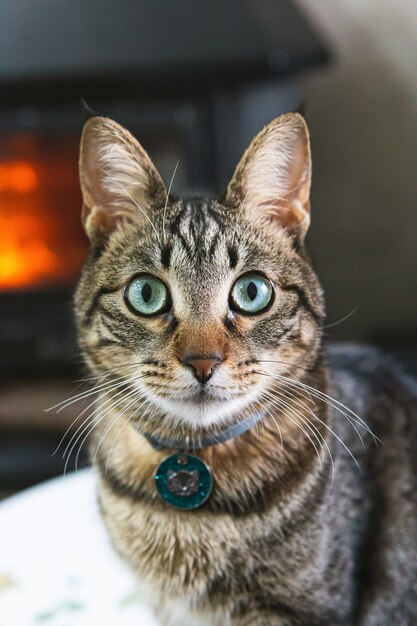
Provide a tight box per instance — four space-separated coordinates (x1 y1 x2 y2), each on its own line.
297 0 417 340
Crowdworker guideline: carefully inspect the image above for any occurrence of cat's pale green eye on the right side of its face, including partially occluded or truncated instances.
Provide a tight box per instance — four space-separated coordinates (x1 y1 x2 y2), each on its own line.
229 273 274 315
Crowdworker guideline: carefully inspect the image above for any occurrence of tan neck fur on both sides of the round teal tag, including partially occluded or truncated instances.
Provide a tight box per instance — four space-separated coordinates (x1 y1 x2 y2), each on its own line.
92 366 331 511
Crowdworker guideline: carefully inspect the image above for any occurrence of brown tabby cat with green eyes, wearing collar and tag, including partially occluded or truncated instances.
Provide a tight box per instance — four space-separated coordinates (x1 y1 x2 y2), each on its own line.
75 113 417 626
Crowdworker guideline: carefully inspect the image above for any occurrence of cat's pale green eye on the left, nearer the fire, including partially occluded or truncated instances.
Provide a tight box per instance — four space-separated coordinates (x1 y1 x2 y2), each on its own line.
125 274 171 315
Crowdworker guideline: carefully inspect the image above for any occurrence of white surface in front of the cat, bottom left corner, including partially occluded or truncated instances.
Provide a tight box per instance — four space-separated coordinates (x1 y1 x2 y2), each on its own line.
0 470 157 626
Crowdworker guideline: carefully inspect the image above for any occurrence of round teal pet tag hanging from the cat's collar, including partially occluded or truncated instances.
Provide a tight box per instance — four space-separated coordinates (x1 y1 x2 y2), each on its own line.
155 452 213 511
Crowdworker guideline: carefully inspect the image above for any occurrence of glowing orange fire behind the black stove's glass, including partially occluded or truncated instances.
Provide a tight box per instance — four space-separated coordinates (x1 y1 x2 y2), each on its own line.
0 150 86 291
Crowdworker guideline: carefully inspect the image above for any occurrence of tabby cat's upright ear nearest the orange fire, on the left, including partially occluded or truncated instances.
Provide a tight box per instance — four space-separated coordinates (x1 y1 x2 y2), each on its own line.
79 117 166 239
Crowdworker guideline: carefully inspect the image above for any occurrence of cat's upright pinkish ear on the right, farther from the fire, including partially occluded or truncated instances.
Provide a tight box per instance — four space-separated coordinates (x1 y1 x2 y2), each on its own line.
226 113 311 239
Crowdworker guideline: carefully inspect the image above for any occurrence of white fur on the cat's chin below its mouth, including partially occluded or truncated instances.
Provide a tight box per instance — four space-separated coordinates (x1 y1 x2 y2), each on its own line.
149 392 257 429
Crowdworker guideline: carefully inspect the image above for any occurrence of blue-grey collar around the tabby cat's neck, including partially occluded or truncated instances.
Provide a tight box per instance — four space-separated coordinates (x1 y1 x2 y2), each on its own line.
132 411 266 451
